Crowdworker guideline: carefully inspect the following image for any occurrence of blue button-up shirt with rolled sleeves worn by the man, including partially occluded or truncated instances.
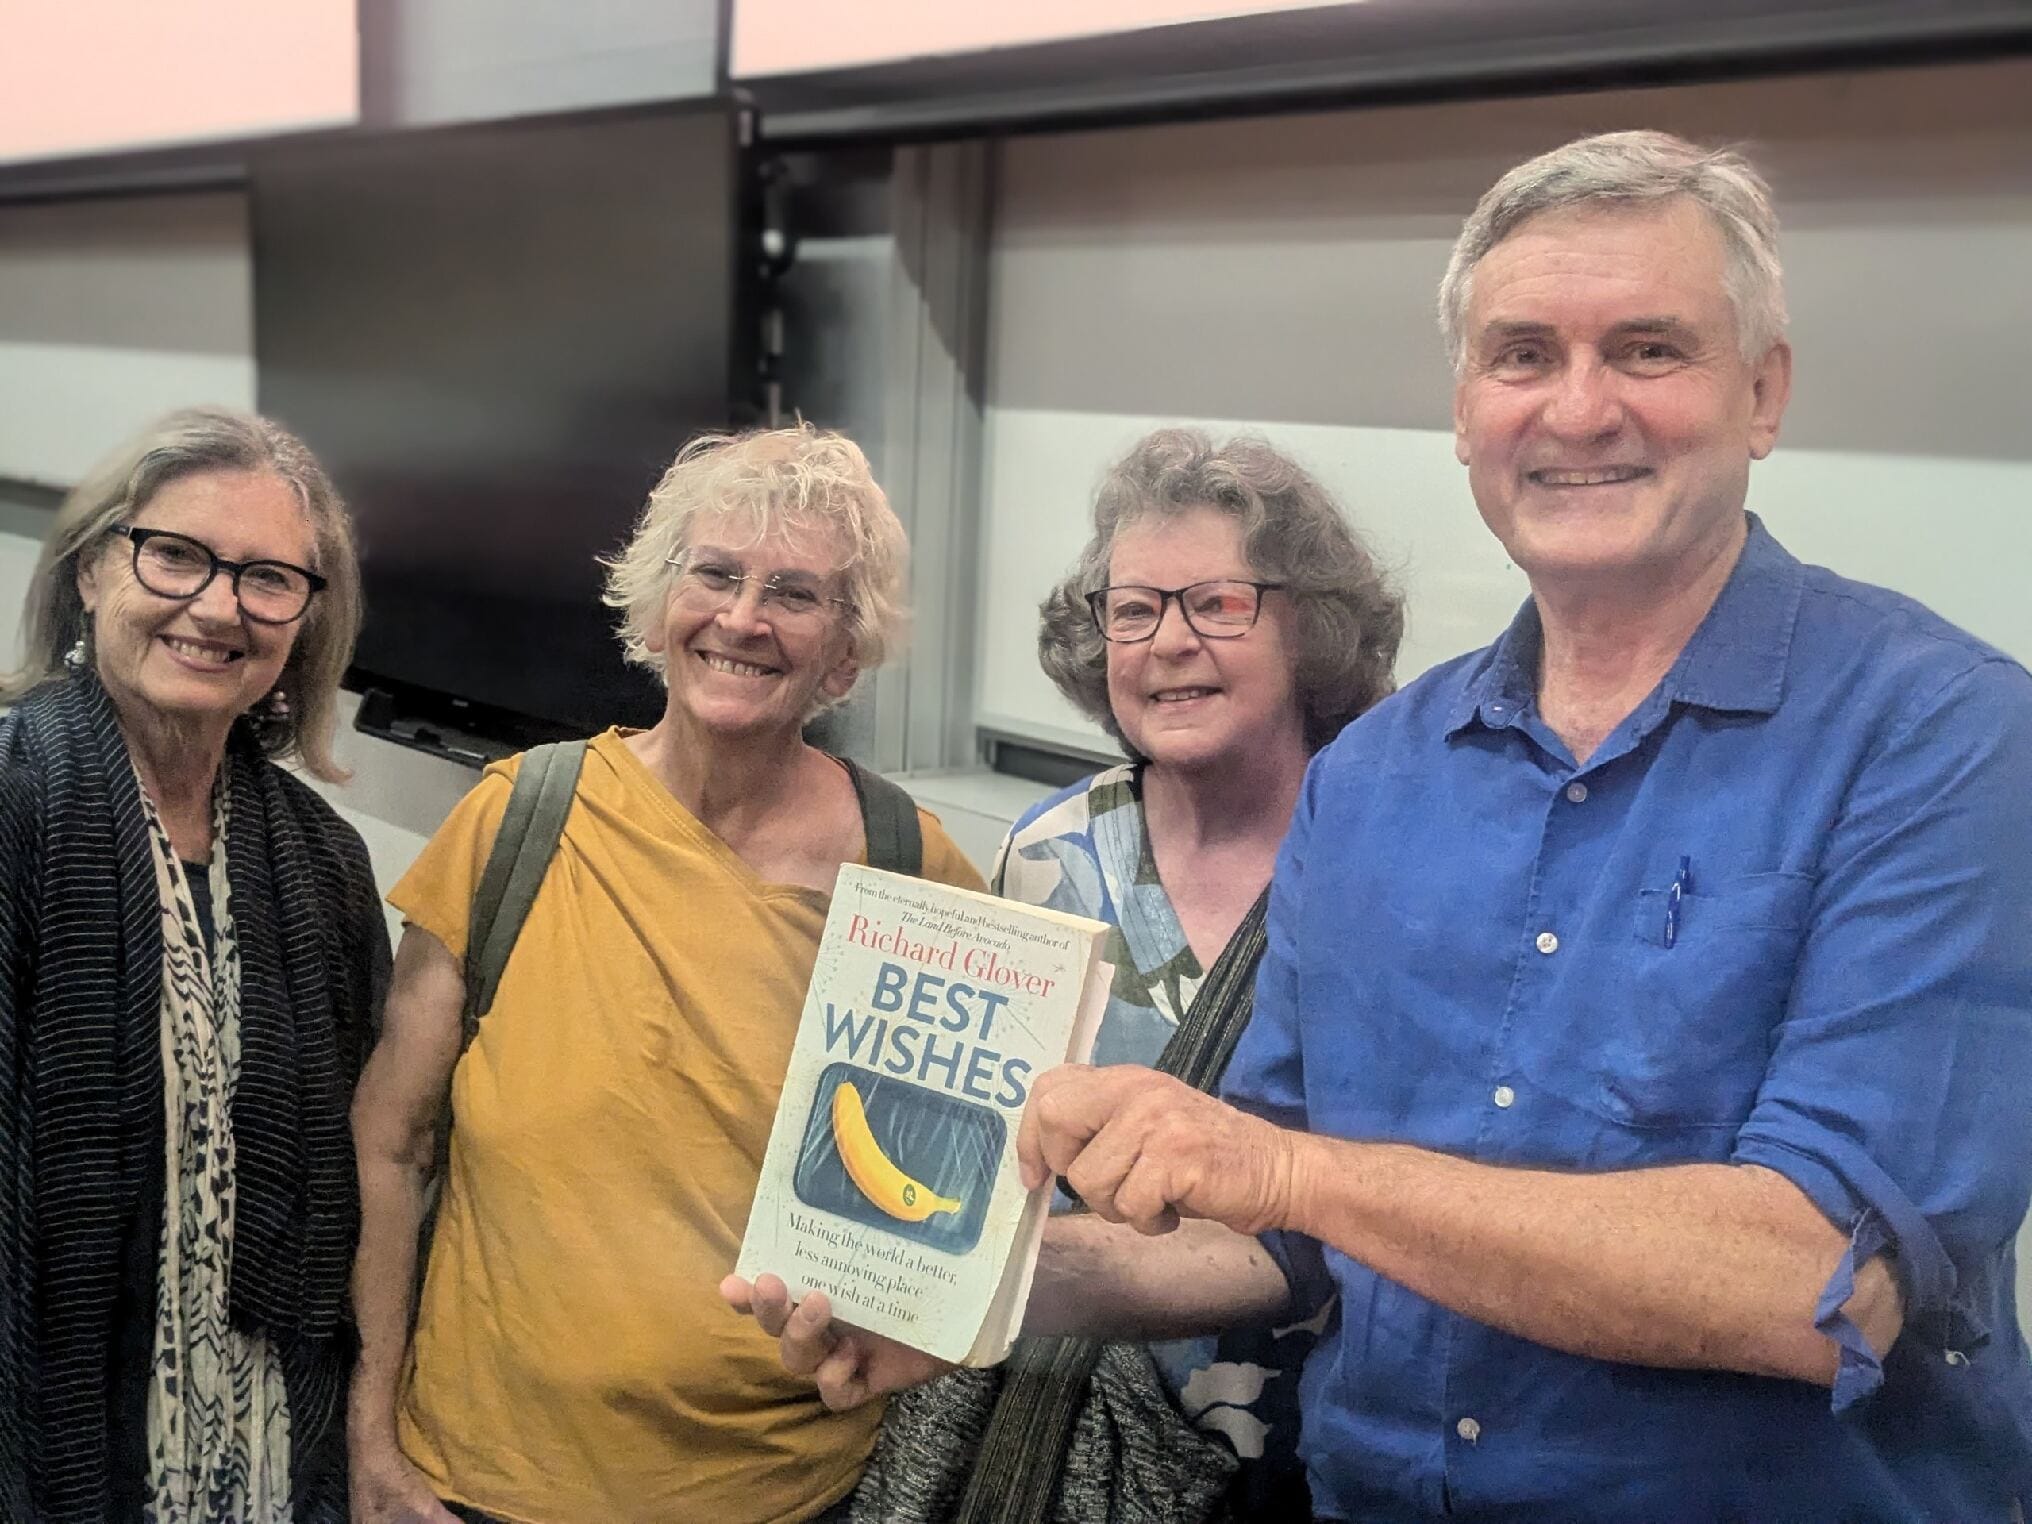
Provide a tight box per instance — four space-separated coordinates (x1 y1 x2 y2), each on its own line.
1227 518 2032 1522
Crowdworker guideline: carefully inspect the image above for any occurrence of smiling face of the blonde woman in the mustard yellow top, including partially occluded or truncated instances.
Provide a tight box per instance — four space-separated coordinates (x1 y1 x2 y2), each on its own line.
644 518 860 738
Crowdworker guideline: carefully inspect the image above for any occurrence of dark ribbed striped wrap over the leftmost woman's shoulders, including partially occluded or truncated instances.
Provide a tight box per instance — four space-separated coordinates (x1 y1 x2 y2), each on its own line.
0 677 388 1524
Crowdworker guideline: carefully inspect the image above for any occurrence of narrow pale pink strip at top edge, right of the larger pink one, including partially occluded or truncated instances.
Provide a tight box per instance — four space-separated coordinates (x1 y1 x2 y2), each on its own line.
729 0 1359 79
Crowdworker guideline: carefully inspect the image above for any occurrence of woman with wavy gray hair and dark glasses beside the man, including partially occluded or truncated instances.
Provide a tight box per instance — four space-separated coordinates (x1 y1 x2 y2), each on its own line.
804 429 1404 1524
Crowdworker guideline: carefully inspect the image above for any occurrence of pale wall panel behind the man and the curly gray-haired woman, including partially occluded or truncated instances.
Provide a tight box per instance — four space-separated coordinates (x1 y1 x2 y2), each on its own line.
979 61 2032 738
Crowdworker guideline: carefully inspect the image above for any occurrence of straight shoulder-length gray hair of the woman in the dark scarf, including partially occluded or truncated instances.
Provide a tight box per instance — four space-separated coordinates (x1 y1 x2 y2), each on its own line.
0 406 360 782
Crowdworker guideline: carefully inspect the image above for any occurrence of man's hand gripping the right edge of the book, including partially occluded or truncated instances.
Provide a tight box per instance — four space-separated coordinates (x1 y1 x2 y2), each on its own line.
1016 1065 1298 1233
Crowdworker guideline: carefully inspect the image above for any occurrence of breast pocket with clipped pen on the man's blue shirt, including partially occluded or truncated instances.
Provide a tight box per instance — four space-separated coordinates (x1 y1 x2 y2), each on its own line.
1595 874 1813 1128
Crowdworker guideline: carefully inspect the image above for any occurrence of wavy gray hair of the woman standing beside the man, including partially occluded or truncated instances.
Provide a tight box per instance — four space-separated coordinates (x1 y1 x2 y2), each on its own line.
1036 429 1404 756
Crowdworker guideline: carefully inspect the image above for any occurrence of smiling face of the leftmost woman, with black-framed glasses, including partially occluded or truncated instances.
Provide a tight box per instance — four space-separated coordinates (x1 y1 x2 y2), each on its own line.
77 471 317 747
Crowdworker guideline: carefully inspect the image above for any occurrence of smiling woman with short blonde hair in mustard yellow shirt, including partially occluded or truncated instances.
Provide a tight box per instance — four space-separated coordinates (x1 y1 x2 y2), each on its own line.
350 427 979 1524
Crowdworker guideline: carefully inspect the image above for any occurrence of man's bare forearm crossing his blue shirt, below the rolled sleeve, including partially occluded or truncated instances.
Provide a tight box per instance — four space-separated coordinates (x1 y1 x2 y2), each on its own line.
1284 1136 1898 1386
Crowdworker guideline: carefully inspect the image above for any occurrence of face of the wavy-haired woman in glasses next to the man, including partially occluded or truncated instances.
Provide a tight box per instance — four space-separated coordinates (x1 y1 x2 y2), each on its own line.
1107 508 1305 768
